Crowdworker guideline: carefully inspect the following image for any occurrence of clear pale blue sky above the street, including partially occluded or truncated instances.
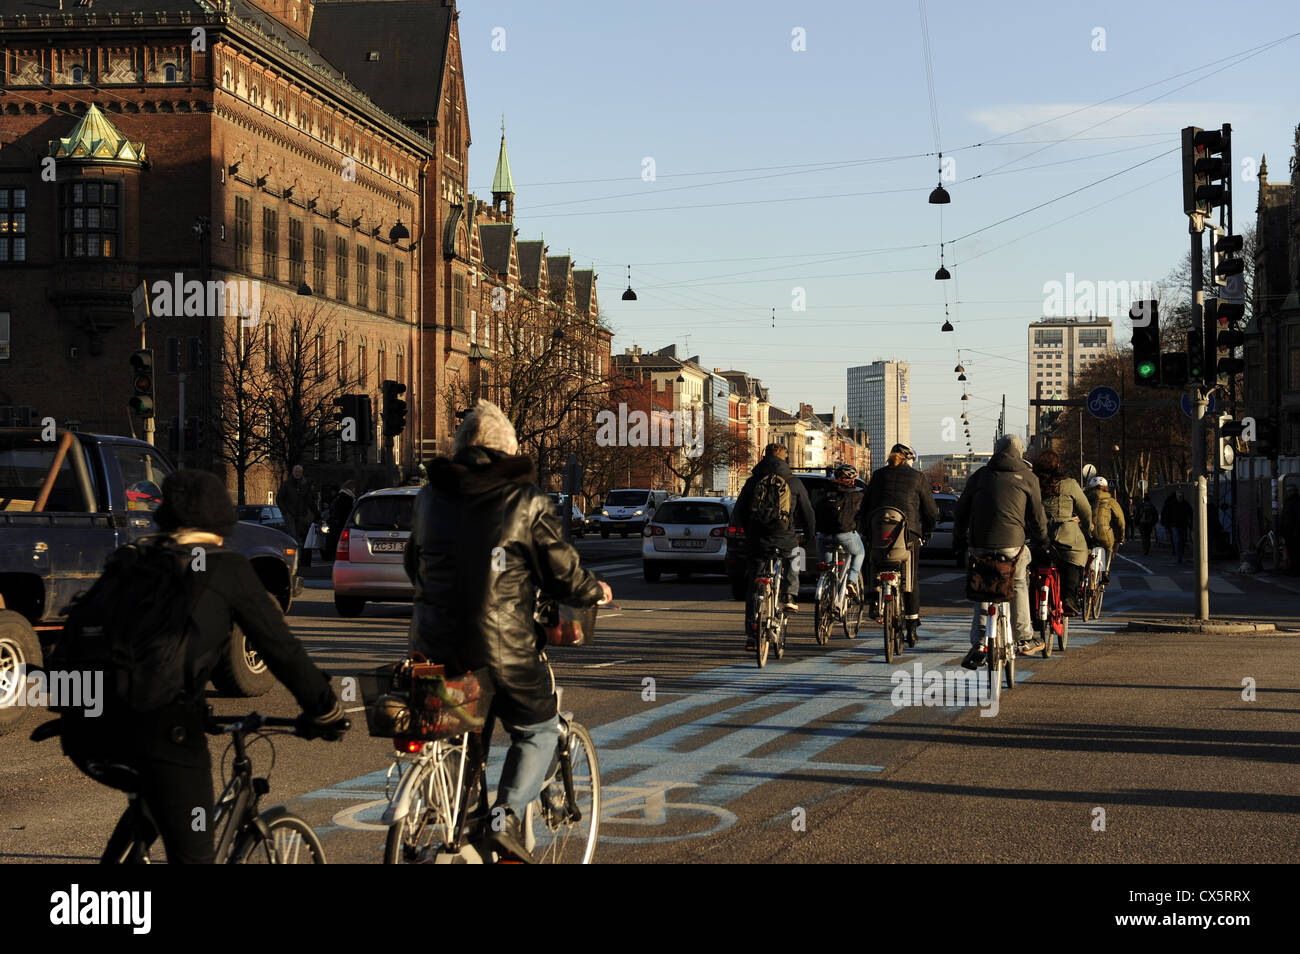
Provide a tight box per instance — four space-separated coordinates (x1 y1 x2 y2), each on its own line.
459 0 1300 454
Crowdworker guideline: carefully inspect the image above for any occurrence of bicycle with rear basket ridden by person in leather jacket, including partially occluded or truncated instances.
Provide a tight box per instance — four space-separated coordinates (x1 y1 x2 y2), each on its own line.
384 696 601 864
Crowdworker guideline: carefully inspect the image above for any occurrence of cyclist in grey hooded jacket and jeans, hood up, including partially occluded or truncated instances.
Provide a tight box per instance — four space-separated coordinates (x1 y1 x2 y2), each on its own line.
953 434 1048 669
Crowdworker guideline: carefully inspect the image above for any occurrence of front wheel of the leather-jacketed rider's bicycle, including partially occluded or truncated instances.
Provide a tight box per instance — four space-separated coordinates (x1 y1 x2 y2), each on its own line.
525 723 601 864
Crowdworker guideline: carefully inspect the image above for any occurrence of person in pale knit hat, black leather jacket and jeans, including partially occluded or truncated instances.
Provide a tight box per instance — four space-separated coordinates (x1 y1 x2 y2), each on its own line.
403 400 612 860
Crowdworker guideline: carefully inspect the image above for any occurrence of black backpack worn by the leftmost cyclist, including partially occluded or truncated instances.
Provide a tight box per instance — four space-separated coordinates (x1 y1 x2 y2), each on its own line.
48 542 194 715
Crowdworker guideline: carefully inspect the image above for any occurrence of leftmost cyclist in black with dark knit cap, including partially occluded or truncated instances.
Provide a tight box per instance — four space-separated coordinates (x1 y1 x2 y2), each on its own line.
61 471 347 864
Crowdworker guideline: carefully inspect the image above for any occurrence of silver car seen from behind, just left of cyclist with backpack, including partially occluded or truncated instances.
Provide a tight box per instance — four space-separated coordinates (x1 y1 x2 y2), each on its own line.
641 496 731 584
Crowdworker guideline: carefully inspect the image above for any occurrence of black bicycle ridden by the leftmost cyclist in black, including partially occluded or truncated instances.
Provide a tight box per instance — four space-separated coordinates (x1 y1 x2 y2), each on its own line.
86 712 338 864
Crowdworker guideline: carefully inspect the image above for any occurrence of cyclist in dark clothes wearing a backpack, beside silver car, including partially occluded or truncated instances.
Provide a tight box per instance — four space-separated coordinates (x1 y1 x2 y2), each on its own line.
732 443 816 650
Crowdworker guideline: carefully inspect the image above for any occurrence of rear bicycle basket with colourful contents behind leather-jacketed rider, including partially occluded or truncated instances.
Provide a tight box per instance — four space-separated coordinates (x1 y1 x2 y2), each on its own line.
358 654 493 742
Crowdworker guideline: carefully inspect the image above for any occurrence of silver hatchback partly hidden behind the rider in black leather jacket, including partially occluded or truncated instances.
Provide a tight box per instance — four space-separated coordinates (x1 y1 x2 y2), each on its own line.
334 487 420 616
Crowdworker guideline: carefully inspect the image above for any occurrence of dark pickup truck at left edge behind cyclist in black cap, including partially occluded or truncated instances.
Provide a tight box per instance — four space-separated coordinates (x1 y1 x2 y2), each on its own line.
0 428 302 734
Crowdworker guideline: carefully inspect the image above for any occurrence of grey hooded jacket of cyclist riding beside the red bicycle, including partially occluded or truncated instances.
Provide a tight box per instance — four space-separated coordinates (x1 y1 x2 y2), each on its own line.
953 452 1048 550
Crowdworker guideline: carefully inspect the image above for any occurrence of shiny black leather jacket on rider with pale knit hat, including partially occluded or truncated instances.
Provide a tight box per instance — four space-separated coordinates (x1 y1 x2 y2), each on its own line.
404 447 601 725
